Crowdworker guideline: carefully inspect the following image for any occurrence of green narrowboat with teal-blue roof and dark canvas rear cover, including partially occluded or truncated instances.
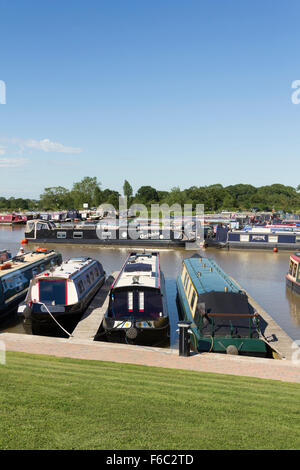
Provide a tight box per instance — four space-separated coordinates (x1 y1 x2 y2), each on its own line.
177 255 267 357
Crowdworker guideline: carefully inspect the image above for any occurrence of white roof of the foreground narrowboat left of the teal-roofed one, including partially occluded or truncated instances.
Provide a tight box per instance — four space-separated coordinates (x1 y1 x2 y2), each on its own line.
111 253 160 289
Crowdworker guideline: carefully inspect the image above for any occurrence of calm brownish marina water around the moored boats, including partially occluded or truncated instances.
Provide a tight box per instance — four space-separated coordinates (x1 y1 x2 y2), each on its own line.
0 226 300 342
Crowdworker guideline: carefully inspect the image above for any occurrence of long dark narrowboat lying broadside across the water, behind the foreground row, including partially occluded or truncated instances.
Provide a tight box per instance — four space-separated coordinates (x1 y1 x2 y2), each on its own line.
25 219 189 248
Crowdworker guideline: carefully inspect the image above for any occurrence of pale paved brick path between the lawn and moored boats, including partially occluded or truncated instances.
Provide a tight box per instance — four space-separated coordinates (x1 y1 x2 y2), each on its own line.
0 333 300 383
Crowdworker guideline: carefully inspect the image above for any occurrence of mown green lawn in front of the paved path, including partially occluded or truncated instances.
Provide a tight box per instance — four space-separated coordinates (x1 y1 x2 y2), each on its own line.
0 352 300 450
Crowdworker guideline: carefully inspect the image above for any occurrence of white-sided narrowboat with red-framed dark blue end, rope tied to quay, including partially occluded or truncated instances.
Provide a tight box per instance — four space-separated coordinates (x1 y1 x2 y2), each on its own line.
18 257 105 336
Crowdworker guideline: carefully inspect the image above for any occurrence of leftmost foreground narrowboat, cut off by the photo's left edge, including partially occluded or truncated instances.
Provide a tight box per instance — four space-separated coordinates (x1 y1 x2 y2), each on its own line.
0 249 62 320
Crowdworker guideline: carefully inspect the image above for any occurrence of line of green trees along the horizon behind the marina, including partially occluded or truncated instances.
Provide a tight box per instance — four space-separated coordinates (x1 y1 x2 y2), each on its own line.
0 176 300 212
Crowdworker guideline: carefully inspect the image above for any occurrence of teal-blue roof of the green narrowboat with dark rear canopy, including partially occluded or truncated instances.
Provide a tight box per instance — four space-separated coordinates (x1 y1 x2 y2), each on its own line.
183 256 243 294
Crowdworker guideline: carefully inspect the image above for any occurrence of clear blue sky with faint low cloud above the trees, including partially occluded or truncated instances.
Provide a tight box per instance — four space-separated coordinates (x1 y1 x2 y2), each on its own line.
0 0 300 197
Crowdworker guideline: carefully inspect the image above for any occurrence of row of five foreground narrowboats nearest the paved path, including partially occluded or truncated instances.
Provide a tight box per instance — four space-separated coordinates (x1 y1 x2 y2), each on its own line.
0 248 300 357
